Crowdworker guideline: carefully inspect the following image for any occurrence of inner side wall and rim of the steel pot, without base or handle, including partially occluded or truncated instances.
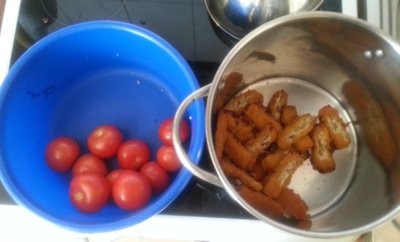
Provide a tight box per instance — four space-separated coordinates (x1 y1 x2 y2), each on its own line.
206 12 400 237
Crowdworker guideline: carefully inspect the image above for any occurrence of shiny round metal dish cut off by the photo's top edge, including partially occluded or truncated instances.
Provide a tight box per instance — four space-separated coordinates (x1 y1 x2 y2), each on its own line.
204 0 324 40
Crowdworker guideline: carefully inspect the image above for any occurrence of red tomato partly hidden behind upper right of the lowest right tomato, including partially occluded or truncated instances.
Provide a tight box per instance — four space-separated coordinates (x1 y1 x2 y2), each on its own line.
140 162 170 194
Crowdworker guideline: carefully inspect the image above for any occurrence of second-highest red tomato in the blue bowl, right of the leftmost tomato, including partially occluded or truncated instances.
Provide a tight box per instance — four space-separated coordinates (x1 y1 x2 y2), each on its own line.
87 125 122 158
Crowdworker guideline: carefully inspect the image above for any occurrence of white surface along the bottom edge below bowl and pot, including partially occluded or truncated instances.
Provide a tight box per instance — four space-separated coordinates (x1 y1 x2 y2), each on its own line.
0 205 358 242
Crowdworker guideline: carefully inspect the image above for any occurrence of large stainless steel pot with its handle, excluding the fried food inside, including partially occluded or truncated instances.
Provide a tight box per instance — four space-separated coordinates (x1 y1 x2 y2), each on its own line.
173 12 400 238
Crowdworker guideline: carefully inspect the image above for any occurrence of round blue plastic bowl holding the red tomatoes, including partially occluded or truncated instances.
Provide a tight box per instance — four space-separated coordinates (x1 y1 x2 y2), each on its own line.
0 21 205 232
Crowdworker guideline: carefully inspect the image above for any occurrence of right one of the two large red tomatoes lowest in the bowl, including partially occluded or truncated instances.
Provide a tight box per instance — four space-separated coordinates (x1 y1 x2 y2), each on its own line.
112 170 151 210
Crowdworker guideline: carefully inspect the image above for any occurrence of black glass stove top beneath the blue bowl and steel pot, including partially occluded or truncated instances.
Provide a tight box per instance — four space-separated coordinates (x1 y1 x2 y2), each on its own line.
0 0 341 219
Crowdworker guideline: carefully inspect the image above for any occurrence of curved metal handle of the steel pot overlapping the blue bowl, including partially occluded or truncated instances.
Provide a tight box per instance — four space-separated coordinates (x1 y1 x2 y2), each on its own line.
172 84 223 187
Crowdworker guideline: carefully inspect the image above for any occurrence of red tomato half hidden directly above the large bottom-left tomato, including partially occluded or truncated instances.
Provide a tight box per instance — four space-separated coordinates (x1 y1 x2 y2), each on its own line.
72 154 108 176
